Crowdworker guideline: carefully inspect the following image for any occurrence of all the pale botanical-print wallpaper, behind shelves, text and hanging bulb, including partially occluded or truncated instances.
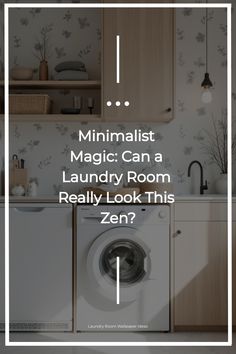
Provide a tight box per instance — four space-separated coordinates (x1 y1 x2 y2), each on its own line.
0 2 236 194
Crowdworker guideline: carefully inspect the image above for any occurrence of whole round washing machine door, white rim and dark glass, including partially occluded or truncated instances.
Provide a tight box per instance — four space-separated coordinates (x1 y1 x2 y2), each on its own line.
87 227 151 302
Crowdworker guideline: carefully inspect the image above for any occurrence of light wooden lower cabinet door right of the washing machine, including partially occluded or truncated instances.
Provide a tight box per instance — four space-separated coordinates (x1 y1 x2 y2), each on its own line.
174 221 227 327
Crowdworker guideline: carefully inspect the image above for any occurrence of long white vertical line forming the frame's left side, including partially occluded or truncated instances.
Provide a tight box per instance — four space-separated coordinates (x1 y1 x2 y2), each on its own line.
4 4 10 346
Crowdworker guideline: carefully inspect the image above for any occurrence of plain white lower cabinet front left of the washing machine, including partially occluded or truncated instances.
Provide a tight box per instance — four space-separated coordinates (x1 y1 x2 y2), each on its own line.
1 203 73 331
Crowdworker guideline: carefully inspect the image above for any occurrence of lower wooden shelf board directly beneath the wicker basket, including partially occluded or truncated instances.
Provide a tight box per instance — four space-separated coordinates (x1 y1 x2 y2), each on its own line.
0 114 102 123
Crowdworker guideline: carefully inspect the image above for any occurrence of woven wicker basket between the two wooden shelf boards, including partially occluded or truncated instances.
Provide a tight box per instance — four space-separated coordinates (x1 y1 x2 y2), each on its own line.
9 94 52 114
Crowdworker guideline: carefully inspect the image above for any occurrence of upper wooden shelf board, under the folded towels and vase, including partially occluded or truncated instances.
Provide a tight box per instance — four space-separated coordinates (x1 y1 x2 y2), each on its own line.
0 80 101 90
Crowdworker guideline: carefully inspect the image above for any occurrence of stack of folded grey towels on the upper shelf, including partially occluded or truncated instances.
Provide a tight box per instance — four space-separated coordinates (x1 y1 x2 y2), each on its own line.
55 61 88 80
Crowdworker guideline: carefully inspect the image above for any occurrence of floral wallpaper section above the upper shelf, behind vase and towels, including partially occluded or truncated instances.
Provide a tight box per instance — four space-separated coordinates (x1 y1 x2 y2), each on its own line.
9 3 101 80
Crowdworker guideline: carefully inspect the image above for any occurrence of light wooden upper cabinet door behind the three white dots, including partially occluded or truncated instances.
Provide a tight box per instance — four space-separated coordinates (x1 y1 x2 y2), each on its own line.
103 9 174 122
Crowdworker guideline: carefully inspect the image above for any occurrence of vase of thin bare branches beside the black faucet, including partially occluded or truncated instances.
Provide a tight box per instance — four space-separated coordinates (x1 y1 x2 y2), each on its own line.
202 112 236 194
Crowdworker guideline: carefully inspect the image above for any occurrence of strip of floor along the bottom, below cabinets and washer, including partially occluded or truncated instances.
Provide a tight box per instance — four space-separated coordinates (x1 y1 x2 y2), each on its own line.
0 333 236 354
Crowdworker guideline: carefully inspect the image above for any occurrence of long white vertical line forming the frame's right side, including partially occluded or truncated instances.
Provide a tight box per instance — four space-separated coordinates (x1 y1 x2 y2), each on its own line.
227 4 232 345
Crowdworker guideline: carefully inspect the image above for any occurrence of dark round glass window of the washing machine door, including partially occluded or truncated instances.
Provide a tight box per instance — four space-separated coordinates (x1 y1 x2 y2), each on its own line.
100 239 146 285
